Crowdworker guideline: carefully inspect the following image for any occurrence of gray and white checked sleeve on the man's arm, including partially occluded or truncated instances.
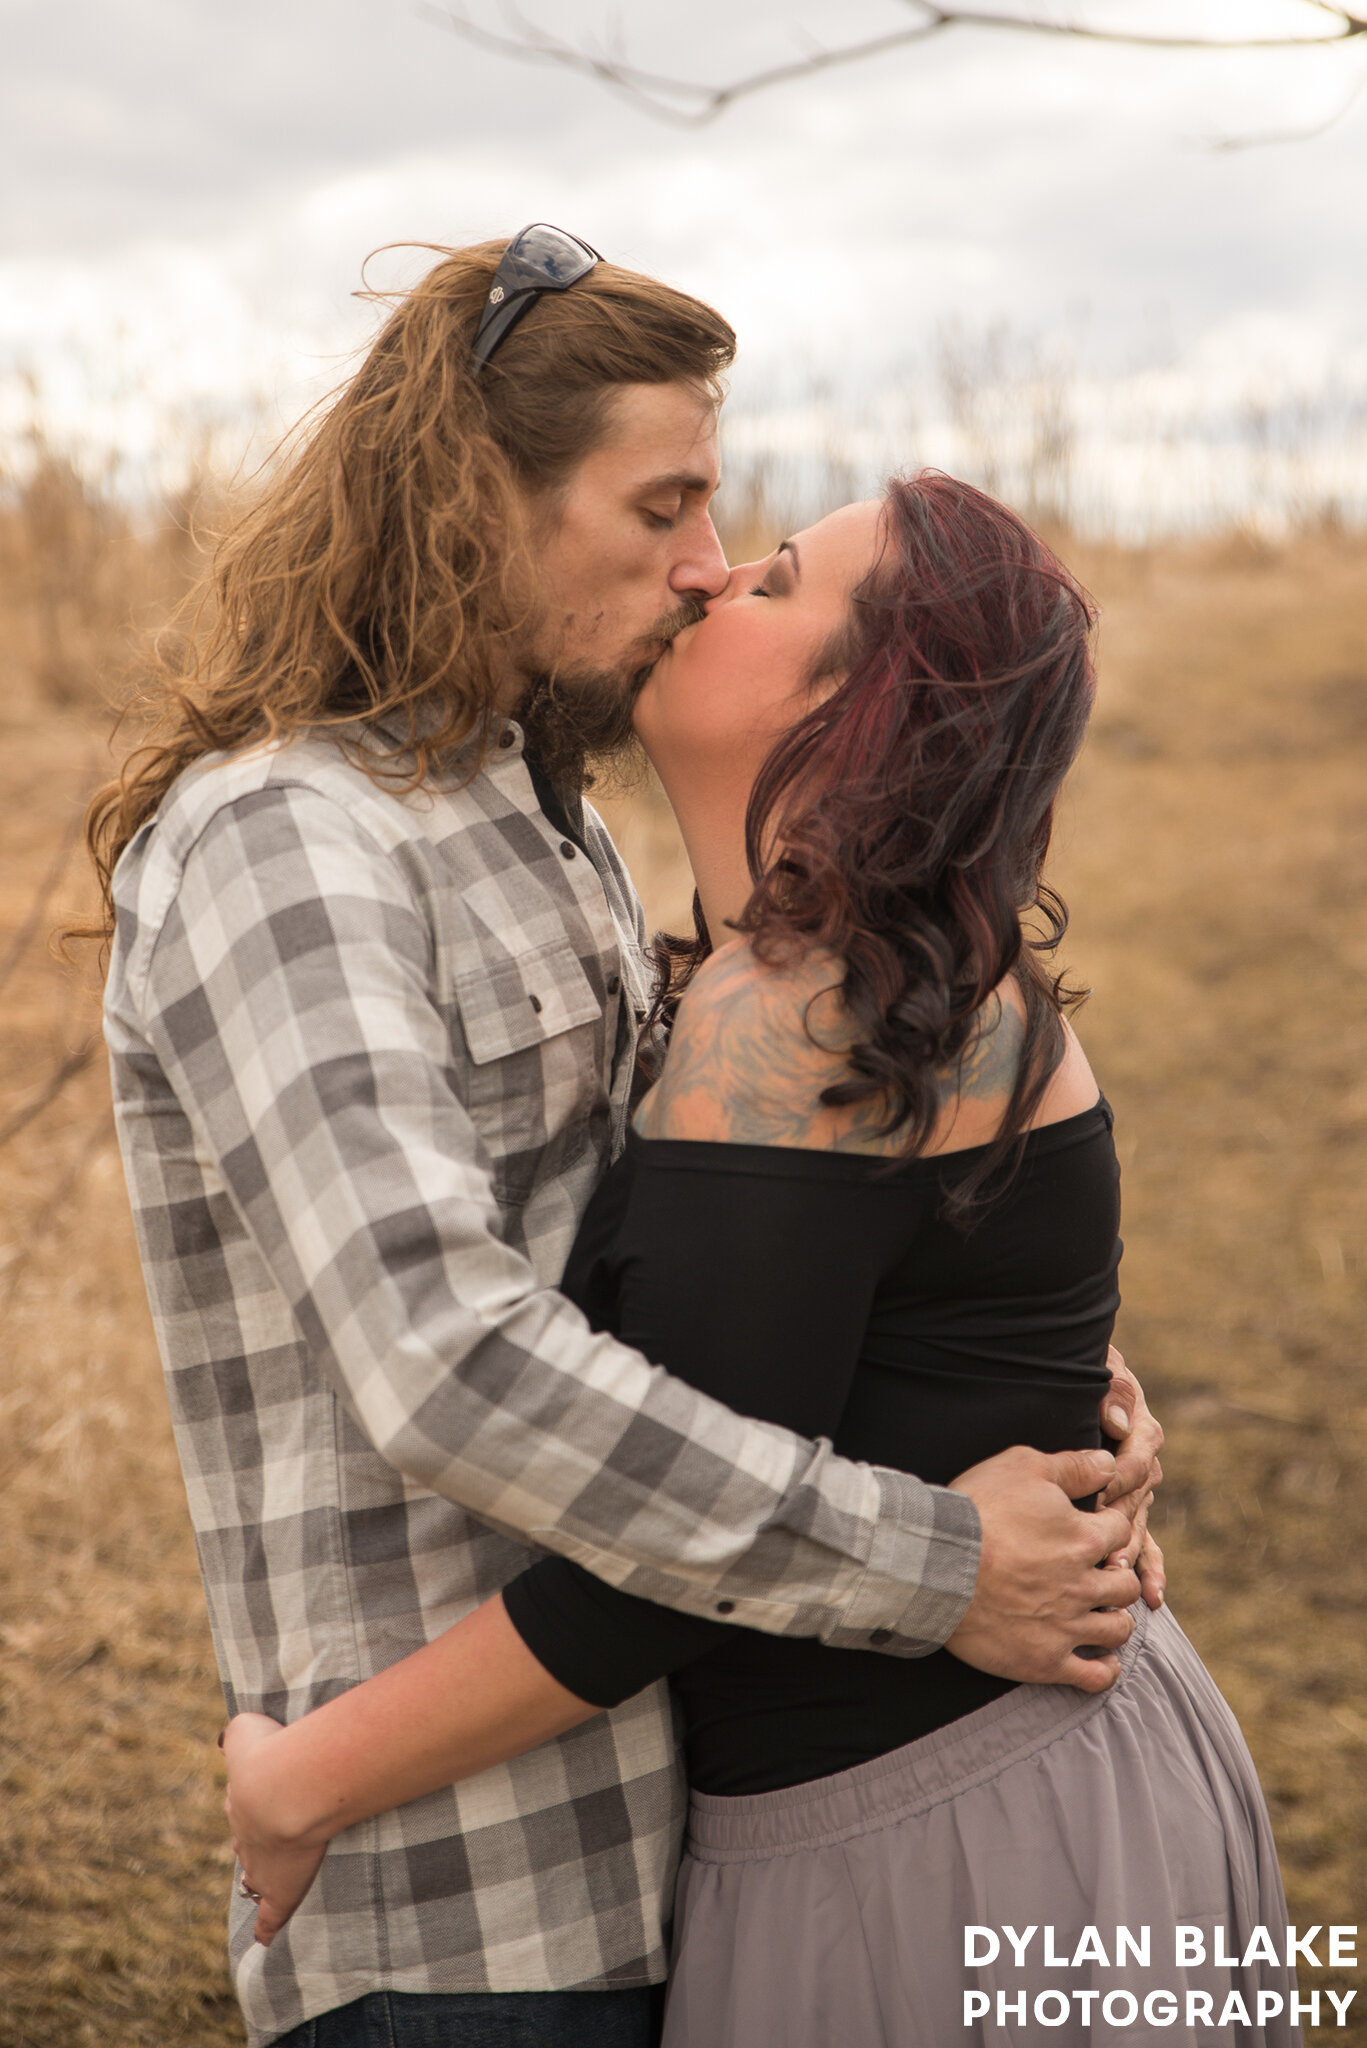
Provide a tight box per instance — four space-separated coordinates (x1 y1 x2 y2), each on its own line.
121 782 978 1655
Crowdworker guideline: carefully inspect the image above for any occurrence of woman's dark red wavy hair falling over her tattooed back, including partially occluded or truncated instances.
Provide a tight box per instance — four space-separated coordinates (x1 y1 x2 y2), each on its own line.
660 471 1094 1221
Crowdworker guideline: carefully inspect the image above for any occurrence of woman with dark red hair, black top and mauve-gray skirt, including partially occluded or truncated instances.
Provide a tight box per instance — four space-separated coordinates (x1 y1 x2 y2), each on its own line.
227 475 1297 2048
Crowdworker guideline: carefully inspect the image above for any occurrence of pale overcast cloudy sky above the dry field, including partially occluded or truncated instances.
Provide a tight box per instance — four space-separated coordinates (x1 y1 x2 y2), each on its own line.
0 0 1367 528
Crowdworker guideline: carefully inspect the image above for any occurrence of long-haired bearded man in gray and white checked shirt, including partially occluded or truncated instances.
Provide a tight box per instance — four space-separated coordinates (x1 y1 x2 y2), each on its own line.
94 229 1158 2048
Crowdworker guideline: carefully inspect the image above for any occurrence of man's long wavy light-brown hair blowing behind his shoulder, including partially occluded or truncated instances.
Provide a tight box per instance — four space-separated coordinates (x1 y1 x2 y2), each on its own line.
86 242 736 932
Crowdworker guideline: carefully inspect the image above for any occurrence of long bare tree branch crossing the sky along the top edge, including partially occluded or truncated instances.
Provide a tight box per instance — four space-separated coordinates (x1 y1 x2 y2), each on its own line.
418 0 1367 129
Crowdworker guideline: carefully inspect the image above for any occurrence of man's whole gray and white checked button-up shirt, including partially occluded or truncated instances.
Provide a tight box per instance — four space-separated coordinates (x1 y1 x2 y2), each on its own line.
107 727 978 2044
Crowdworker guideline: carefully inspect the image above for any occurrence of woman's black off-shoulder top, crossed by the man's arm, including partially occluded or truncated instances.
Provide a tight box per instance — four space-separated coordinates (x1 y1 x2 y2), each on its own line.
504 1102 1121 1794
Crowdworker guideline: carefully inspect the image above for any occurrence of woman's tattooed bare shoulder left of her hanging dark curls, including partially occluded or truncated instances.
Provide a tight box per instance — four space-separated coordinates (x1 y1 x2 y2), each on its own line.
635 938 848 1149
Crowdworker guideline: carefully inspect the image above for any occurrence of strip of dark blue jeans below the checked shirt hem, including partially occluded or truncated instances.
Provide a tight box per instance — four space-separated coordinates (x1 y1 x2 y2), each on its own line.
273 1985 664 2048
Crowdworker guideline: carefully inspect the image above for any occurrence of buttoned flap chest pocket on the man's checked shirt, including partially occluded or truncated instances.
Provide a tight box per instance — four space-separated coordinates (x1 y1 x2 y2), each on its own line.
451 940 607 1200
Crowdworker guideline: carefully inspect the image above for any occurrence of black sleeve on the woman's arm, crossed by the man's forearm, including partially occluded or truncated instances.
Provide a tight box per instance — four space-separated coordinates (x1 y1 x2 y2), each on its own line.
504 1141 909 1706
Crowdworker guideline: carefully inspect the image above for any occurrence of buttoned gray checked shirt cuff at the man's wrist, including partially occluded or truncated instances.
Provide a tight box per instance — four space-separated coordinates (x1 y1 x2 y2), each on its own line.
822 1466 982 1657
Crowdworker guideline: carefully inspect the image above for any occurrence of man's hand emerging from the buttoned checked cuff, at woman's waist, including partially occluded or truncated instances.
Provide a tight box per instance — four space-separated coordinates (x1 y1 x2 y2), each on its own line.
945 1444 1140 1692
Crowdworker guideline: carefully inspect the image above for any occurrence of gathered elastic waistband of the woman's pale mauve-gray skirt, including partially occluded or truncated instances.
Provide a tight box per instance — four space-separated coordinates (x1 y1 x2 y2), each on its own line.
687 1599 1166 1864
